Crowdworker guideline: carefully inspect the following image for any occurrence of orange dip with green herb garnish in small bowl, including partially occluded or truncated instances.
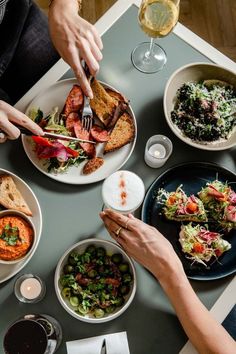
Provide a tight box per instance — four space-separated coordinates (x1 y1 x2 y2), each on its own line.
0 215 33 261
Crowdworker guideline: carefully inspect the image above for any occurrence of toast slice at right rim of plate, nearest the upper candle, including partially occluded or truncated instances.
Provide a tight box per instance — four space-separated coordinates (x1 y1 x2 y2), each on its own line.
104 113 135 154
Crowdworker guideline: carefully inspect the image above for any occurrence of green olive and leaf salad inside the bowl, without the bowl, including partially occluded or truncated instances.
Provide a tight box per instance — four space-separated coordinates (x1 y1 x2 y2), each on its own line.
59 245 133 318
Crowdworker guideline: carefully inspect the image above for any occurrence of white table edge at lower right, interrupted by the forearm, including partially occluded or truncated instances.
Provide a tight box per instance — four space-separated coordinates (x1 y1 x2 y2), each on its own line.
179 276 236 354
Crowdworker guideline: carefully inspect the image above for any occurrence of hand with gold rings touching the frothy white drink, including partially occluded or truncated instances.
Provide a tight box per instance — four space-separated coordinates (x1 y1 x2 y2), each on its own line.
100 210 185 282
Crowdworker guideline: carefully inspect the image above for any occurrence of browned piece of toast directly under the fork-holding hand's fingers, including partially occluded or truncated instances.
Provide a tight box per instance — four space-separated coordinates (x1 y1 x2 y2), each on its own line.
90 80 118 126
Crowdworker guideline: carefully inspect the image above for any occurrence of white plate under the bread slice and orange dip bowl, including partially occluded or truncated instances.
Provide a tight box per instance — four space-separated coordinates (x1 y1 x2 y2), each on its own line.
0 168 42 283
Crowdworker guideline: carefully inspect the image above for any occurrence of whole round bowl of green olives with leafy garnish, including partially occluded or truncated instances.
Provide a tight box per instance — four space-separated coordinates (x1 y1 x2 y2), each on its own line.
54 238 136 323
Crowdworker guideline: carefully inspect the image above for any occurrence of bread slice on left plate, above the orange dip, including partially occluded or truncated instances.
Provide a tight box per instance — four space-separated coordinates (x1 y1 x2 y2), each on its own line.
0 175 32 216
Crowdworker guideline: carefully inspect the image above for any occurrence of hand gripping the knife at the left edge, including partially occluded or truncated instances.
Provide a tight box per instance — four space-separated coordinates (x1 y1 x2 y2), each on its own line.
0 101 43 143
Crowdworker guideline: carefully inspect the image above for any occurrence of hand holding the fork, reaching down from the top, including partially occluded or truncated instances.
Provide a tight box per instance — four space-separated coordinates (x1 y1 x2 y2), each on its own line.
49 0 103 98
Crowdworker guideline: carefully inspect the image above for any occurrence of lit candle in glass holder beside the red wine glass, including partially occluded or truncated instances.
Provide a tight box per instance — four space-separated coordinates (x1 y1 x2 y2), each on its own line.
14 274 46 303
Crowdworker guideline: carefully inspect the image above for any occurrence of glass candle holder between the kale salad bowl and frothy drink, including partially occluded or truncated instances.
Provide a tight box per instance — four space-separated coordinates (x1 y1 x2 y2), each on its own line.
144 135 173 168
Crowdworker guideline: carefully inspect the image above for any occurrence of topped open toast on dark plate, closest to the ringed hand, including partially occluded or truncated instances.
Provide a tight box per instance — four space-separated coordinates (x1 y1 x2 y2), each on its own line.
179 223 231 266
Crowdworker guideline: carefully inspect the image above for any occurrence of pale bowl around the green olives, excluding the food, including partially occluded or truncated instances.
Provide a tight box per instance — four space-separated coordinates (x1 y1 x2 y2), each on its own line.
54 238 136 323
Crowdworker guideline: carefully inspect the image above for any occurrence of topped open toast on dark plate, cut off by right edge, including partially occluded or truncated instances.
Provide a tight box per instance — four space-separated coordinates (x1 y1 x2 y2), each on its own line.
198 180 236 232
